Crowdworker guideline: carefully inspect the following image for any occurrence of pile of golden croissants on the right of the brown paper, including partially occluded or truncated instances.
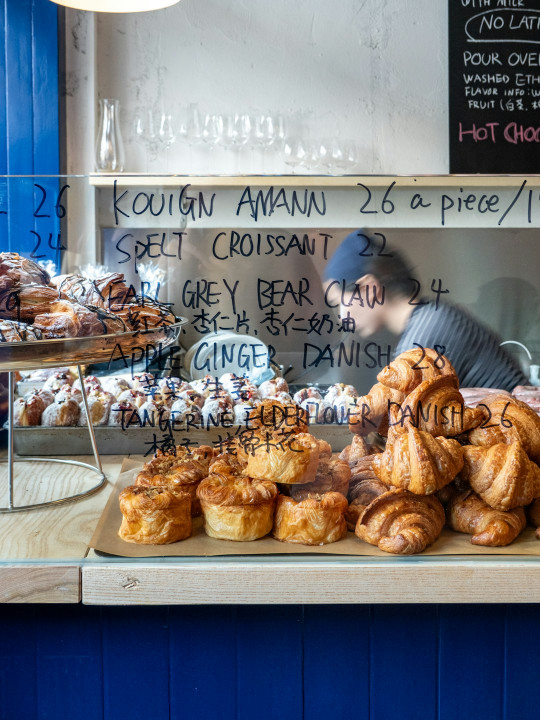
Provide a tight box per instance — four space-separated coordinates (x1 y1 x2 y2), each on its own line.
348 349 540 554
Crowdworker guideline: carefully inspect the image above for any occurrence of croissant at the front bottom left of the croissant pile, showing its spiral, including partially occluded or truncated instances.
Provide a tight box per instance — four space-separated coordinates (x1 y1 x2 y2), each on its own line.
355 489 445 555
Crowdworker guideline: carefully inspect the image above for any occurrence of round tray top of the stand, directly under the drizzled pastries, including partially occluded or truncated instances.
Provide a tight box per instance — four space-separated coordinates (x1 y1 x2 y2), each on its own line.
0 318 187 372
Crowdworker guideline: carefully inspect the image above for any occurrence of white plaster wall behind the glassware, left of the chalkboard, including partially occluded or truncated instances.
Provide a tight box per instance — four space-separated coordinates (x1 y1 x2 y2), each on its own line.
67 0 448 174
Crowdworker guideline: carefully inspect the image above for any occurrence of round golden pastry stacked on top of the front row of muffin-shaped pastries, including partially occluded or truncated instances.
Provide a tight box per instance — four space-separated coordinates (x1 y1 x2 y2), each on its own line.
247 433 320 485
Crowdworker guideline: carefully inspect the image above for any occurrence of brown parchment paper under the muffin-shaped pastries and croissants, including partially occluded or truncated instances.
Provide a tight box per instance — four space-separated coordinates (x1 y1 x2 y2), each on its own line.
90 458 540 558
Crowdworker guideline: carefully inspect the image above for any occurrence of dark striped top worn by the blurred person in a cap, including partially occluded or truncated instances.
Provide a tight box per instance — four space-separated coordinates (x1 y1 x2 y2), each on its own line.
395 303 528 390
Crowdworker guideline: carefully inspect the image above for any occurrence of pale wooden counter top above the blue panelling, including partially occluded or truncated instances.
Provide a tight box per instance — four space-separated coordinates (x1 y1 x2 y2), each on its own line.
0 456 540 605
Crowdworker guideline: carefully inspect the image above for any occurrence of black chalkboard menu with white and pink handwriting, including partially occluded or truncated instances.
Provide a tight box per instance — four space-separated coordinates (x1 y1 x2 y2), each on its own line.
448 0 540 174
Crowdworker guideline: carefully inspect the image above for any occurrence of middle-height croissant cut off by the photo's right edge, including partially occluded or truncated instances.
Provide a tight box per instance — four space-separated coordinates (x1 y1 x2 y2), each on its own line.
461 442 540 510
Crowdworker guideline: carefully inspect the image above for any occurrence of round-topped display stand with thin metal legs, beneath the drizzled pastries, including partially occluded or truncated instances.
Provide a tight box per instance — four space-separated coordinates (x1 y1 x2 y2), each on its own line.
0 319 186 513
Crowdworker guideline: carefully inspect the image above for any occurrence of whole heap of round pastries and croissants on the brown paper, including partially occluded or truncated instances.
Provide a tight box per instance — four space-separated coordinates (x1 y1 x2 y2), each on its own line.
119 349 540 554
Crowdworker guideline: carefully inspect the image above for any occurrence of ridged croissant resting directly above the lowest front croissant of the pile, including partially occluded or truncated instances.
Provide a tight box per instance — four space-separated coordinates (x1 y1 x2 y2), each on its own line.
373 425 463 495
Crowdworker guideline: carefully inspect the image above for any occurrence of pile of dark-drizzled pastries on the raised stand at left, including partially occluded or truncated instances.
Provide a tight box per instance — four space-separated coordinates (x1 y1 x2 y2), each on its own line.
0 252 176 342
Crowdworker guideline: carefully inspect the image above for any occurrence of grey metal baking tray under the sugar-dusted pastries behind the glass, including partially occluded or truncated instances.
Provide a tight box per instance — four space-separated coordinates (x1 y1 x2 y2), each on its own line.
9 424 353 457
